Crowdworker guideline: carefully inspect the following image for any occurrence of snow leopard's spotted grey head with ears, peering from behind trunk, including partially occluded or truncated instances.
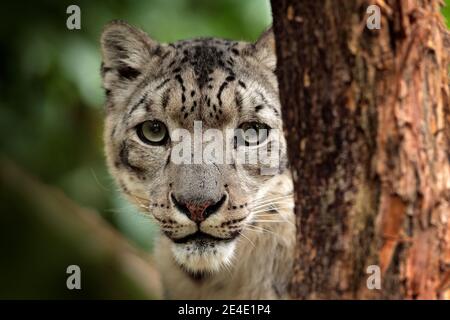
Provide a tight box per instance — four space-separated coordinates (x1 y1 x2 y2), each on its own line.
101 21 286 273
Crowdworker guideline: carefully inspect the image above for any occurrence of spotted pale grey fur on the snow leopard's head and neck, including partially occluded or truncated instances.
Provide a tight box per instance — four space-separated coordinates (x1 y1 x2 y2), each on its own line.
101 21 295 299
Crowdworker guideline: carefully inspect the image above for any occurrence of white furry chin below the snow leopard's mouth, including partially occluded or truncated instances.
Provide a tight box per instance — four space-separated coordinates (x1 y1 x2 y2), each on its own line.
171 241 236 273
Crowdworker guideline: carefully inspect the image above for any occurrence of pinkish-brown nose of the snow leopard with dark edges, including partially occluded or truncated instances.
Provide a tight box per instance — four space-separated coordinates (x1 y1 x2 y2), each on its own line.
171 193 226 223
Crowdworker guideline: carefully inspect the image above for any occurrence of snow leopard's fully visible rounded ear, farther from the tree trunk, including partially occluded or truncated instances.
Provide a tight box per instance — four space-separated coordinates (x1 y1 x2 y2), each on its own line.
100 20 161 80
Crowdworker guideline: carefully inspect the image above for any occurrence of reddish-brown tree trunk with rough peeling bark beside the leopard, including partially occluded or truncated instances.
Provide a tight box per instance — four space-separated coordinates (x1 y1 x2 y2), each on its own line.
272 0 450 299
